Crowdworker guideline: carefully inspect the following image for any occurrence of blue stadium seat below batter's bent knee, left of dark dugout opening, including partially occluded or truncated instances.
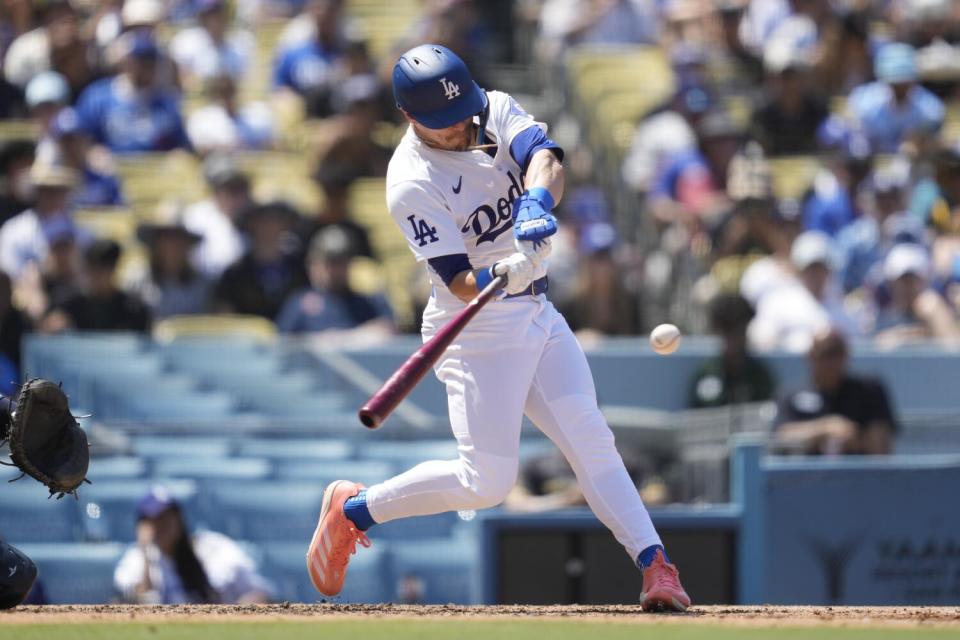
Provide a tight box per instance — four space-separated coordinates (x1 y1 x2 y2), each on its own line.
390 538 479 604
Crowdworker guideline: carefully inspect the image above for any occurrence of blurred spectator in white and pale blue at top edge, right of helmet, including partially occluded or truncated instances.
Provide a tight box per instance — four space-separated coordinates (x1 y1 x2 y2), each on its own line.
540 0 659 62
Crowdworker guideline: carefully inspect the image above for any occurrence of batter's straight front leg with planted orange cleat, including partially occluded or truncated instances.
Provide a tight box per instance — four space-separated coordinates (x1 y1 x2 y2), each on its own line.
526 309 690 610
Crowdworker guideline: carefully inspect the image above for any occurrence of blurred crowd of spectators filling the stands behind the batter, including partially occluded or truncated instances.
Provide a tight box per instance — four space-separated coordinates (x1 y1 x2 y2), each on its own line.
0 0 960 384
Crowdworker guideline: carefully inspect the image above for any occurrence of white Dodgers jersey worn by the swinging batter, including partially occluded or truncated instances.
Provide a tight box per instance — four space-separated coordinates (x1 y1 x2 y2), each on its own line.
387 91 547 311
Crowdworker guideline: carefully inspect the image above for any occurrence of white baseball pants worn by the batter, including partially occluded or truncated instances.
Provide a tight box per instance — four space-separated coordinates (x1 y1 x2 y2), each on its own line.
367 295 660 560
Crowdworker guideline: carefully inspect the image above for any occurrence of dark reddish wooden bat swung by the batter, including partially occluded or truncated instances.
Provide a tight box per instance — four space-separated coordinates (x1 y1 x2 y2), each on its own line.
358 276 507 429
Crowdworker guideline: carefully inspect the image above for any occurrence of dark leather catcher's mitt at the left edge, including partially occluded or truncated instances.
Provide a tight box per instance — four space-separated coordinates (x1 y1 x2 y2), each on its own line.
0 378 90 499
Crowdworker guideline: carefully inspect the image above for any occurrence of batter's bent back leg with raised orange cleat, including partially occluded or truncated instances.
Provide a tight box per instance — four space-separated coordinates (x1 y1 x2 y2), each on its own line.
307 316 546 595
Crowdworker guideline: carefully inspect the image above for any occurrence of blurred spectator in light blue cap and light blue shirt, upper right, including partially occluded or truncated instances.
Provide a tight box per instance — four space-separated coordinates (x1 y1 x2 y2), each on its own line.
847 42 946 153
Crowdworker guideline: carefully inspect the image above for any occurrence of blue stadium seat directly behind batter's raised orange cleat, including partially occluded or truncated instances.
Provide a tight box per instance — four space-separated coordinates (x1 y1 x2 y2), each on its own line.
262 540 392 602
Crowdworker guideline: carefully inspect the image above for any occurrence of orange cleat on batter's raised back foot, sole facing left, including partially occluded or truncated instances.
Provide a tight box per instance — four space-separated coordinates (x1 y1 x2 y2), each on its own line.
307 480 370 596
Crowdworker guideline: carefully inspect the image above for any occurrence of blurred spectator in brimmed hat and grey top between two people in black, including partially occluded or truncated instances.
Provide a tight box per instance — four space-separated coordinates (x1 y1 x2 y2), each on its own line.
126 203 212 320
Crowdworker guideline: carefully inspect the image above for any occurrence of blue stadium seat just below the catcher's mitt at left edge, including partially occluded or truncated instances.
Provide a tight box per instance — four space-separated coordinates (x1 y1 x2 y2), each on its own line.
0 476 80 543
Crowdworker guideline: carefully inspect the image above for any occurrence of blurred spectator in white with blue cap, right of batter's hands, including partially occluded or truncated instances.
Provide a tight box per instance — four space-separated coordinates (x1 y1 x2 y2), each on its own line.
623 85 713 193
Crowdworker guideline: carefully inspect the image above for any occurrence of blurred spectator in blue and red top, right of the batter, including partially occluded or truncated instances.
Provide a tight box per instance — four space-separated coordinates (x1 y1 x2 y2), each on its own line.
648 111 742 226
